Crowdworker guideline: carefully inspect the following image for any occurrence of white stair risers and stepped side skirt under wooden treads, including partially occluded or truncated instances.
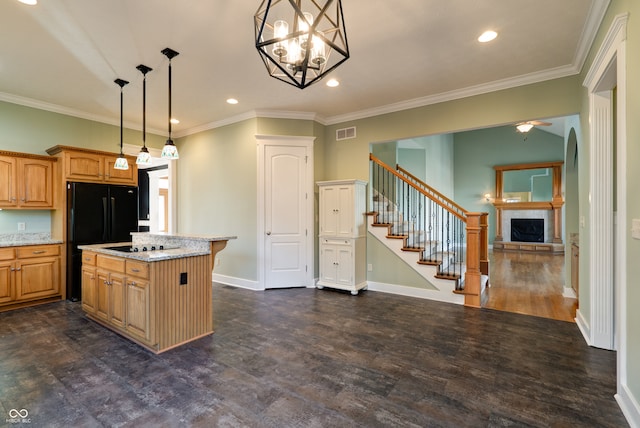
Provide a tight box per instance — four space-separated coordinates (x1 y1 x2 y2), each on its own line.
367 220 464 305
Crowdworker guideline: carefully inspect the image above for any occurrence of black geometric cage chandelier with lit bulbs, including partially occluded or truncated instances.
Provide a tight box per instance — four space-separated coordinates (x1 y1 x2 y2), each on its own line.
254 0 349 89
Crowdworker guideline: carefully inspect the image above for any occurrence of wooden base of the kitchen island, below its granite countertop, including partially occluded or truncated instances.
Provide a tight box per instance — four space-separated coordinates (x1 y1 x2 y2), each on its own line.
83 251 213 353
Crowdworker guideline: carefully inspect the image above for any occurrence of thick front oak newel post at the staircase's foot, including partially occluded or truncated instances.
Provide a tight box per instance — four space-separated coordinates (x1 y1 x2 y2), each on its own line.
464 213 483 308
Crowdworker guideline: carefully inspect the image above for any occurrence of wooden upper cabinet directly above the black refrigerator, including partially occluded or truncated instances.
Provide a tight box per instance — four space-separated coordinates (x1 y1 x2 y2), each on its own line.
47 146 138 186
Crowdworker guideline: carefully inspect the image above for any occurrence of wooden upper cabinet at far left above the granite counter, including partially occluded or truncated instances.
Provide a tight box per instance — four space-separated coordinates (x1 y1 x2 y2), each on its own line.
0 152 57 209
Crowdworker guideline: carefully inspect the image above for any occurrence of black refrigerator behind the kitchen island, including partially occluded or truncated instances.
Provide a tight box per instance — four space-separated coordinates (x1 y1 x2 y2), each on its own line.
67 183 138 301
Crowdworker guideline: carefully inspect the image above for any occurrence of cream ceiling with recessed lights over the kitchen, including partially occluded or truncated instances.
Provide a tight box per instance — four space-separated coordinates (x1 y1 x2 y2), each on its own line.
0 0 609 137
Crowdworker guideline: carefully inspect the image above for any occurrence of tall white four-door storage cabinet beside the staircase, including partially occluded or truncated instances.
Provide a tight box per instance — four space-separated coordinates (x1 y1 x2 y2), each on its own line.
317 180 367 295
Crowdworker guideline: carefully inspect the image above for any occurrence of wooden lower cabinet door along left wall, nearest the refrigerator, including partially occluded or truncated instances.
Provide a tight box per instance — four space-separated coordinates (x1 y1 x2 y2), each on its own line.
16 257 60 300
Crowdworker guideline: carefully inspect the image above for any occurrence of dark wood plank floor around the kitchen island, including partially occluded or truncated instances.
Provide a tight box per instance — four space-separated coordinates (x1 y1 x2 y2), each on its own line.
0 284 627 427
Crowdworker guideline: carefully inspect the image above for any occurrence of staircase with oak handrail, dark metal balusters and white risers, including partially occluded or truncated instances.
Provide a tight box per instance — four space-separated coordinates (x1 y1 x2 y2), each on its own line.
368 154 489 307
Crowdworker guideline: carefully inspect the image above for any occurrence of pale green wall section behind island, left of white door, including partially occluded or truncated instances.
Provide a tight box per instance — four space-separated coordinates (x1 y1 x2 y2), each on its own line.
177 119 258 281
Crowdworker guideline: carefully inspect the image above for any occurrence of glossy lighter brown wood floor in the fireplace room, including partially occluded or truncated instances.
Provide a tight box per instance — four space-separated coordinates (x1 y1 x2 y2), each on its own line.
483 251 578 322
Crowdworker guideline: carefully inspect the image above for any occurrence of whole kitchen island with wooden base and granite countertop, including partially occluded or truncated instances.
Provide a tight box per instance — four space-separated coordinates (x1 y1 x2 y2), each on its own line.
78 233 236 353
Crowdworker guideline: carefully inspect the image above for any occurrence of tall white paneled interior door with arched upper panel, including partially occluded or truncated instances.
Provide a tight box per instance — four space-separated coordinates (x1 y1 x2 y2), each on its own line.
261 135 313 288
